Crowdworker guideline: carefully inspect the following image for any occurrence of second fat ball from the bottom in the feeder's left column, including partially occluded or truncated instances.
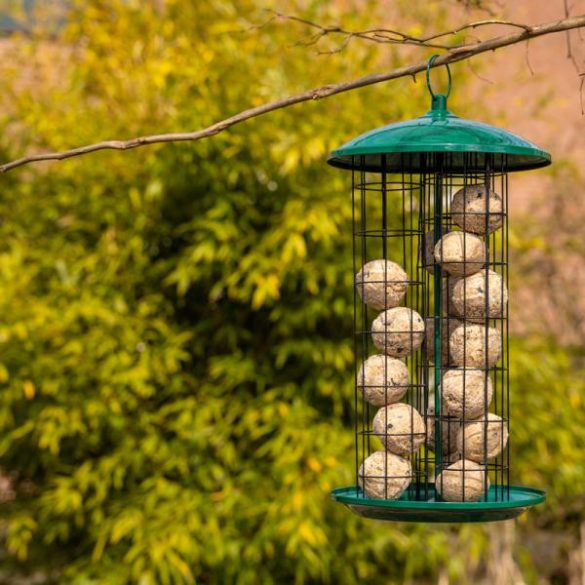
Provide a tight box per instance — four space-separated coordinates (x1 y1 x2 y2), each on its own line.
374 402 426 455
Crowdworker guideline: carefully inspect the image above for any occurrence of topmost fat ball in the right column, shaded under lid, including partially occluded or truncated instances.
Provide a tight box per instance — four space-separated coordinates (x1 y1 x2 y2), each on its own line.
451 185 504 235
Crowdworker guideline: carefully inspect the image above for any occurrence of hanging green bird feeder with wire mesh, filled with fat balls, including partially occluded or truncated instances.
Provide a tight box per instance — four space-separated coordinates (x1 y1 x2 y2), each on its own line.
328 56 551 522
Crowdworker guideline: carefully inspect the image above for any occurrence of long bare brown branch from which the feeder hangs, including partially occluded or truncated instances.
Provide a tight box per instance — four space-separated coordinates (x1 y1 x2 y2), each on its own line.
0 15 585 173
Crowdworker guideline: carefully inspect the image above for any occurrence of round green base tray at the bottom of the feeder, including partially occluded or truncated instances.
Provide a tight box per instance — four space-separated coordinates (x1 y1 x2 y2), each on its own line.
331 486 546 523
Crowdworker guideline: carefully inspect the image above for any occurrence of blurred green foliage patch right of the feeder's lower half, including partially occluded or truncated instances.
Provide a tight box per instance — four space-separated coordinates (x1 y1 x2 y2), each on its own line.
511 338 585 496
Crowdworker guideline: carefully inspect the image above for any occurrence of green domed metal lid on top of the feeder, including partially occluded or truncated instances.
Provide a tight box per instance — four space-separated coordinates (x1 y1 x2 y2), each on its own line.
327 94 551 173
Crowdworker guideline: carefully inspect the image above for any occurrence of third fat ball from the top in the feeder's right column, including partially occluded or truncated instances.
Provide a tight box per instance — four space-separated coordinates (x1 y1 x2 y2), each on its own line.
452 270 508 322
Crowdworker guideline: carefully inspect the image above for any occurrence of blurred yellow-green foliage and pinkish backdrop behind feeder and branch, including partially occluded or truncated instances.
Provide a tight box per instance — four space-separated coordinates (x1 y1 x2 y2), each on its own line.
0 0 585 585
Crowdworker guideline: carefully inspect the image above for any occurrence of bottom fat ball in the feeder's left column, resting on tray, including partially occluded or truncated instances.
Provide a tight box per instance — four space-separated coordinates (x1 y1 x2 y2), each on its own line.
358 451 412 500
